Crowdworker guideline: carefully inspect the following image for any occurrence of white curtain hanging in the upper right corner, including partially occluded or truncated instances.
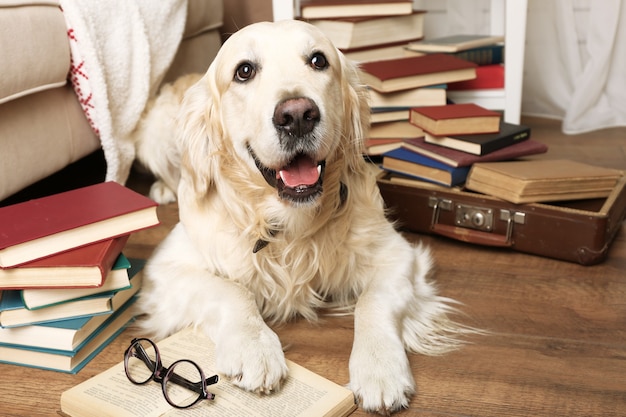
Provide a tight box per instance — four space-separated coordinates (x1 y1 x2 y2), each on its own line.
513 0 626 134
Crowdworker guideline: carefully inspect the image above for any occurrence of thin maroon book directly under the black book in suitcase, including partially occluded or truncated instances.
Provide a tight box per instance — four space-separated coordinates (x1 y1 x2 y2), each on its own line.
398 138 548 167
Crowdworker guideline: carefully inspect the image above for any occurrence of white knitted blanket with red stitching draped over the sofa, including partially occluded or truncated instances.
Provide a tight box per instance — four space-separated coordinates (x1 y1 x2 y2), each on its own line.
60 0 187 184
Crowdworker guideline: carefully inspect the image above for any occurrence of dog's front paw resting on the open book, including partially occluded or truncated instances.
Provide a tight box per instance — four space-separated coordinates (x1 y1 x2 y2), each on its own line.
215 327 288 394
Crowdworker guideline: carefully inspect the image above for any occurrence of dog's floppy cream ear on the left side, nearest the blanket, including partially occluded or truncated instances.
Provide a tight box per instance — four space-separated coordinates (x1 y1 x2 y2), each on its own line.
177 65 223 194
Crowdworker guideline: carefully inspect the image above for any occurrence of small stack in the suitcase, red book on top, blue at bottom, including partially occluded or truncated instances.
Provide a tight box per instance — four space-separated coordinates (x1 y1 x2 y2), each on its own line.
382 103 548 187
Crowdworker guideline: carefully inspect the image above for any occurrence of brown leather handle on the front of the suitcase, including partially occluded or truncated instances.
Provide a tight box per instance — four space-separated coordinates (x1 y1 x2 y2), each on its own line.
430 199 514 247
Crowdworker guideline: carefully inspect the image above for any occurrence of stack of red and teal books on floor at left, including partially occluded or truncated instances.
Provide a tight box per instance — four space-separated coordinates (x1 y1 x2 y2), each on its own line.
0 182 159 373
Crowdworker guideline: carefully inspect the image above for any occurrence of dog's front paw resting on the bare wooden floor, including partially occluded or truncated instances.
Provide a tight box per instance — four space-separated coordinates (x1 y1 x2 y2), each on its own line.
350 352 415 415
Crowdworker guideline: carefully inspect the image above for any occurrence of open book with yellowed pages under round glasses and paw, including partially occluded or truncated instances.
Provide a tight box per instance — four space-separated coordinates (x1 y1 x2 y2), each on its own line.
61 329 356 417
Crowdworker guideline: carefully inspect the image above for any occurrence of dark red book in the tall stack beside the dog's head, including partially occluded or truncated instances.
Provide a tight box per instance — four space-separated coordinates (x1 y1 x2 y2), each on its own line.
360 54 477 93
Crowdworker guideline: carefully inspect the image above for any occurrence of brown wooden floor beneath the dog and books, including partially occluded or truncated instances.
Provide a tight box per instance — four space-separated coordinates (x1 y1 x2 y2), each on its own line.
0 115 626 417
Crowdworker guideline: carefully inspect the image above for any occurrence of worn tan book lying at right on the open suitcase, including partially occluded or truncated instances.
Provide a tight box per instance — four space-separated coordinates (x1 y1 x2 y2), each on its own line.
466 159 624 204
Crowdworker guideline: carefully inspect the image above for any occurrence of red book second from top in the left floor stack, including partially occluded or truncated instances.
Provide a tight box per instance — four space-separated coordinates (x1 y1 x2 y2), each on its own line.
0 235 128 289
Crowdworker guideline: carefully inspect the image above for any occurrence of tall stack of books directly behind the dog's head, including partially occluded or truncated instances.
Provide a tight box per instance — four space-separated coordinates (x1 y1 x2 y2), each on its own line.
300 0 450 145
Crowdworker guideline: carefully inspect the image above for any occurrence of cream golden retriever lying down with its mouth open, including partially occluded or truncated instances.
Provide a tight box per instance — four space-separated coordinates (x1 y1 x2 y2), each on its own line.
139 21 463 414
